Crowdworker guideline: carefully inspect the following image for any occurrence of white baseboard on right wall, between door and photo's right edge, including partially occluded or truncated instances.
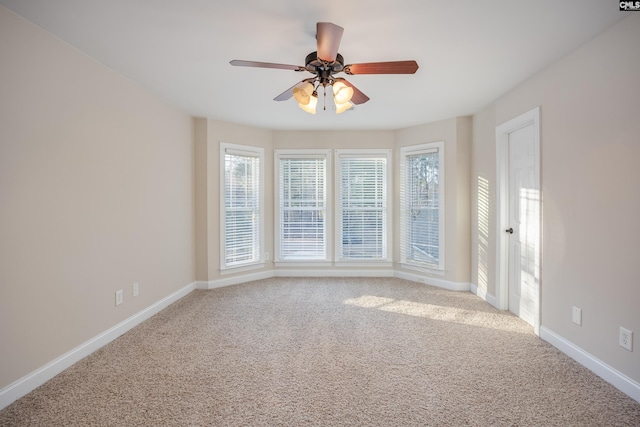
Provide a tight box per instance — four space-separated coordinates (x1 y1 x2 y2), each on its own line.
540 326 640 403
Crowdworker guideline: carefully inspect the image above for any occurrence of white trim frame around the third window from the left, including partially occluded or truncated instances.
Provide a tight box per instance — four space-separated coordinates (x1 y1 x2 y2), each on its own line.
334 149 393 266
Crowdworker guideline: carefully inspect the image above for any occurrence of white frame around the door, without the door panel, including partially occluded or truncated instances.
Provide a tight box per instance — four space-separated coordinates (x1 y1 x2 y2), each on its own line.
496 107 542 335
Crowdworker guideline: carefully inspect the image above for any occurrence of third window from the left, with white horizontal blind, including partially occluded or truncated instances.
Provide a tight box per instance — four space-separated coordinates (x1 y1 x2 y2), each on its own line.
336 150 391 261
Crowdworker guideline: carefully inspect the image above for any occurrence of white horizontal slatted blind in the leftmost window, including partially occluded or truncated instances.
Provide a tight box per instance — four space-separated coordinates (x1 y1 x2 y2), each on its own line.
224 150 260 267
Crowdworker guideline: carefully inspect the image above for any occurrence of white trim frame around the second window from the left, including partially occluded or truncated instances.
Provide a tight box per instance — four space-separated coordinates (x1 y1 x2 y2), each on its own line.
273 149 333 267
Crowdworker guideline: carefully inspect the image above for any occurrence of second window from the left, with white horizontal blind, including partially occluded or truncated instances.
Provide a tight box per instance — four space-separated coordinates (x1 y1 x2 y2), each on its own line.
275 150 330 261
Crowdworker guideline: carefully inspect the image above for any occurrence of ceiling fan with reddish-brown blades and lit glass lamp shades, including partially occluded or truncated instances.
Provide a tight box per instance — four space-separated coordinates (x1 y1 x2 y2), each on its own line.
230 22 418 114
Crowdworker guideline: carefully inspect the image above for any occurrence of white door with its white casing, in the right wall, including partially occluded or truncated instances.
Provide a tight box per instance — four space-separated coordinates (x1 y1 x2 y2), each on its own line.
496 108 542 334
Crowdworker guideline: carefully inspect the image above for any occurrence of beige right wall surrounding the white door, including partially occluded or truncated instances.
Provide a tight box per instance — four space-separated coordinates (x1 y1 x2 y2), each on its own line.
472 14 640 382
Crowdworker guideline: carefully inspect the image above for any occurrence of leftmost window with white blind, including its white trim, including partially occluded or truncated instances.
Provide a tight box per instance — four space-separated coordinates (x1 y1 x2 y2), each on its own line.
220 143 264 270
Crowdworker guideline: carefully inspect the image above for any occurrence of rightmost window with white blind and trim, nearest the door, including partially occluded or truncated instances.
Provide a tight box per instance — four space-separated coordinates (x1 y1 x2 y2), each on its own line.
400 142 444 271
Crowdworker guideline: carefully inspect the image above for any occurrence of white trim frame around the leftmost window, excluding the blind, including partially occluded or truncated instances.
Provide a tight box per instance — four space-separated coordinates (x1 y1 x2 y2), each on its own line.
219 142 265 274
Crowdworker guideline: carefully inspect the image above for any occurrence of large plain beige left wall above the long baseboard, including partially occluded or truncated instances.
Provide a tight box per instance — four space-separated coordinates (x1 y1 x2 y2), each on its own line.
0 7 195 389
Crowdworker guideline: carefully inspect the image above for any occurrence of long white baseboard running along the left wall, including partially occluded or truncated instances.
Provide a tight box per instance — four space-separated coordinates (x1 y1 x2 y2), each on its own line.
0 282 196 410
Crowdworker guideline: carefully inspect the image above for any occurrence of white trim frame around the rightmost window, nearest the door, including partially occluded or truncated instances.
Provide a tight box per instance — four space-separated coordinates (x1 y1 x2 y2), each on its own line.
400 141 446 275
